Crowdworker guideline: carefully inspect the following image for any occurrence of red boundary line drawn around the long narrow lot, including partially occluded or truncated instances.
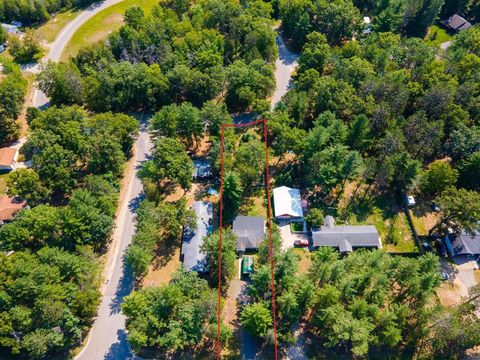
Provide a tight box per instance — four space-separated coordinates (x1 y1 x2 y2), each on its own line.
217 119 278 360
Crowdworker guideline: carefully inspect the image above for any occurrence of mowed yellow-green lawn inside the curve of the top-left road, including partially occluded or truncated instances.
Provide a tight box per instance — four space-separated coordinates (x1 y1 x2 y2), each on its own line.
60 0 159 61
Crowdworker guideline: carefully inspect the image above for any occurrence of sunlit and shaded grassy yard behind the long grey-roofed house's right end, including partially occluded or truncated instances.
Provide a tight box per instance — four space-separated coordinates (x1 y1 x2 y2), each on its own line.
348 195 418 252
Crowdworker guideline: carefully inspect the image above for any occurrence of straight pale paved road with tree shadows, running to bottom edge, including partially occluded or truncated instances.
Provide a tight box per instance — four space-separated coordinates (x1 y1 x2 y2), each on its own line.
76 124 152 360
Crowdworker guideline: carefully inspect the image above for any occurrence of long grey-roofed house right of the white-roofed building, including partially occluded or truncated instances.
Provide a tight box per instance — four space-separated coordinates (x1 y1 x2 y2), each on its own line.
312 216 382 253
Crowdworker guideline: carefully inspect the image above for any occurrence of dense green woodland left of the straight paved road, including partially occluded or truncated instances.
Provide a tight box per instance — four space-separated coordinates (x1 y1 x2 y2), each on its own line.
0 104 138 359
